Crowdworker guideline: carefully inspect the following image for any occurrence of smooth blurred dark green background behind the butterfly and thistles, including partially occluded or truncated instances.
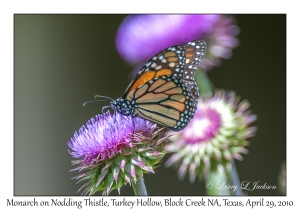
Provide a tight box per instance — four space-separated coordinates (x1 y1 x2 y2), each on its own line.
14 14 286 196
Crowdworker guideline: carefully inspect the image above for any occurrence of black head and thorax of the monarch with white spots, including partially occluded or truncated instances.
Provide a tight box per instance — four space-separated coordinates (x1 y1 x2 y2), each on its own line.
110 98 135 116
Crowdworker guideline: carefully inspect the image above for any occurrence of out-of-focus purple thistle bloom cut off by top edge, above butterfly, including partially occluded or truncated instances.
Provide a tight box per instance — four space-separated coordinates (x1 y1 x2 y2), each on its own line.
116 15 239 70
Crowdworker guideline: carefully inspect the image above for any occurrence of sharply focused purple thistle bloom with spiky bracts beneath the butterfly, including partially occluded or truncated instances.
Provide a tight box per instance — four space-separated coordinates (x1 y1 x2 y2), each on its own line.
68 112 166 195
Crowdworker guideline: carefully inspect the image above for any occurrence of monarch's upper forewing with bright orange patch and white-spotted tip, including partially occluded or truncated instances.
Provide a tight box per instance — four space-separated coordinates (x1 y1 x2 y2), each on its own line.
124 40 206 105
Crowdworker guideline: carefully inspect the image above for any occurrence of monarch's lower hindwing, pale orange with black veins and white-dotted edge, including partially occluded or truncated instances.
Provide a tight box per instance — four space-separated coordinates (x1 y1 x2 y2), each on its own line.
127 75 195 130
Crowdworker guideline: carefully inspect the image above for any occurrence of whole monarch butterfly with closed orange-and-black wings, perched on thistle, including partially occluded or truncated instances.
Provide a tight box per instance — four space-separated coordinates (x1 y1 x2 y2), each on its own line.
110 40 206 131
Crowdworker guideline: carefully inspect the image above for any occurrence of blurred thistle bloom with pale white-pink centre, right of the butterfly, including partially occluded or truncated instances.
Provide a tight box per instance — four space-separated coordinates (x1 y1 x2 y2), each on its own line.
166 91 256 182
